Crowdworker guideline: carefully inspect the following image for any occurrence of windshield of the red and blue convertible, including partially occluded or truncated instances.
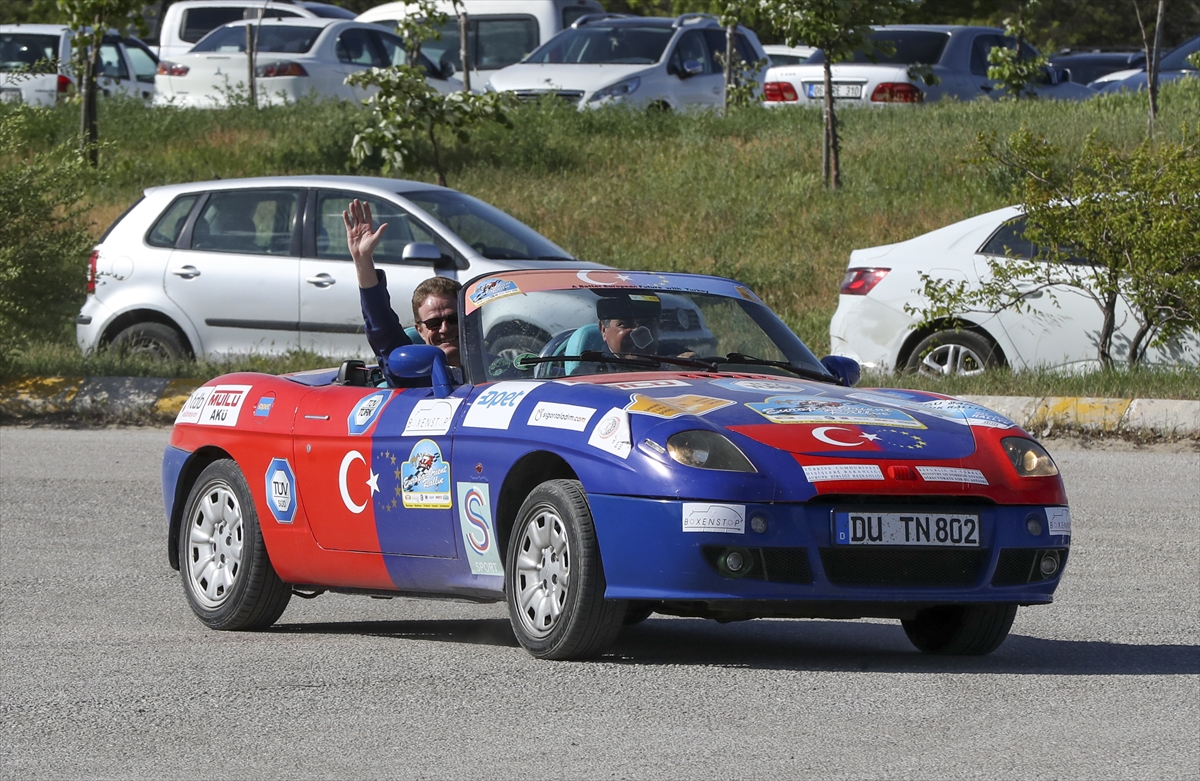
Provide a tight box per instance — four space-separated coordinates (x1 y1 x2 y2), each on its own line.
463 270 830 380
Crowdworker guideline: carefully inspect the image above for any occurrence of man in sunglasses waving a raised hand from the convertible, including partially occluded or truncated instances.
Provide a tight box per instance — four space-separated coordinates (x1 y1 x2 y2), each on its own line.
342 198 462 366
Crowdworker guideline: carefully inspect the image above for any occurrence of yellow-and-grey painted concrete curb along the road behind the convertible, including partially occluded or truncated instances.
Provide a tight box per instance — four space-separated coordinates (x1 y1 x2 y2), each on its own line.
0 377 1200 438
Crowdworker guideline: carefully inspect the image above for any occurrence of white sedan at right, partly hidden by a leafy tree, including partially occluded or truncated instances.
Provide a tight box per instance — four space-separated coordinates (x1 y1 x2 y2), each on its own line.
829 206 1200 374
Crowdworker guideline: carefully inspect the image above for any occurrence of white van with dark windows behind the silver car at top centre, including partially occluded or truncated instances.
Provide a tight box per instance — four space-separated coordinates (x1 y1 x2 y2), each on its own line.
359 0 604 86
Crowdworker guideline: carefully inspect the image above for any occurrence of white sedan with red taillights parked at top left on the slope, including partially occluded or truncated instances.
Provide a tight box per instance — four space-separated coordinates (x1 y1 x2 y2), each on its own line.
155 18 462 108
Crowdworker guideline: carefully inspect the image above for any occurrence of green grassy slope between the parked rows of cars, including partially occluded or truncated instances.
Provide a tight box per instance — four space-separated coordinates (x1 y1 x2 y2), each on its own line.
0 79 1200 397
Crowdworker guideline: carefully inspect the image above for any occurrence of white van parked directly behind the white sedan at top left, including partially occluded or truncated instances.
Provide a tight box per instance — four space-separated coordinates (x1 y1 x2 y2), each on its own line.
158 0 354 60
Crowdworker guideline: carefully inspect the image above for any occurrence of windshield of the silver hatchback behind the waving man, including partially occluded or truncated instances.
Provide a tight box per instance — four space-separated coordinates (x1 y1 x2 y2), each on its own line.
398 190 572 260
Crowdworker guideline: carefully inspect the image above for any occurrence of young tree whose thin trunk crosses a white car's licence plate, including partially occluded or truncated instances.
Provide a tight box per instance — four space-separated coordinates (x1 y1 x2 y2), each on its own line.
760 0 908 188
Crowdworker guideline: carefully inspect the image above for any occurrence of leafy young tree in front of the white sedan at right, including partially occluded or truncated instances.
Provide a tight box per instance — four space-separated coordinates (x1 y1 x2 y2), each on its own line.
913 130 1200 367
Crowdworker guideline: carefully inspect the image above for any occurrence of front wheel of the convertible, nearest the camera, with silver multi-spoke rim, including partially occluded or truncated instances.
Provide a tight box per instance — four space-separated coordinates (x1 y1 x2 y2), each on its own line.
504 480 625 660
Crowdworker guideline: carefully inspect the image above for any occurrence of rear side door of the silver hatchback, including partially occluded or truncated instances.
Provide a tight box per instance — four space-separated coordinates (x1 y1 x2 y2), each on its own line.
163 188 304 354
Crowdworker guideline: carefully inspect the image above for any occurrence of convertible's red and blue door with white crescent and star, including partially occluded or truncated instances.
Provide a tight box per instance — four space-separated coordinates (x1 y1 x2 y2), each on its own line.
294 386 470 558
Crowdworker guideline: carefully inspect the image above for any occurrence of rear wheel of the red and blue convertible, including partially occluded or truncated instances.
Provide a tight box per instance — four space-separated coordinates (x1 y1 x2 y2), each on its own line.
179 459 292 631
